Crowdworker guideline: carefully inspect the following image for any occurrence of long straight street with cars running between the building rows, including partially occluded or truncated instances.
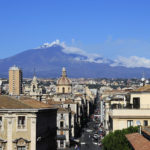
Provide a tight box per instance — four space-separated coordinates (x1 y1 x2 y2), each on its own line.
66 89 102 150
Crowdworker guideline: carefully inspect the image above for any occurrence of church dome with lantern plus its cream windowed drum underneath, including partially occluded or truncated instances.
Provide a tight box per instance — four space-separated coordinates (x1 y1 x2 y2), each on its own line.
56 67 72 94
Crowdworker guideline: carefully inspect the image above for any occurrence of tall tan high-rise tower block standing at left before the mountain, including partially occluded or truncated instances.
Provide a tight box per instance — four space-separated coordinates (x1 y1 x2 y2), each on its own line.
9 66 22 95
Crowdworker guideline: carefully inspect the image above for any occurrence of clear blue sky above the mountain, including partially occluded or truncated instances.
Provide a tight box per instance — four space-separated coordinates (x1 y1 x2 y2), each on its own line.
0 0 150 67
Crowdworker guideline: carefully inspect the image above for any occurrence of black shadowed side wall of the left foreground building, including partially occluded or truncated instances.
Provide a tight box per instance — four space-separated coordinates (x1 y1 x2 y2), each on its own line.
36 109 57 150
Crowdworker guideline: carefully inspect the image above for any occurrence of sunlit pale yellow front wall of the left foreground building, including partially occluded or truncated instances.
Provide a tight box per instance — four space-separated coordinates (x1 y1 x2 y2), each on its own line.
0 112 36 150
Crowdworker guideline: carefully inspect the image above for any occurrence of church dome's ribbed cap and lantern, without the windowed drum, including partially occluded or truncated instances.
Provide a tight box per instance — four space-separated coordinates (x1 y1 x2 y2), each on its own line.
57 67 71 85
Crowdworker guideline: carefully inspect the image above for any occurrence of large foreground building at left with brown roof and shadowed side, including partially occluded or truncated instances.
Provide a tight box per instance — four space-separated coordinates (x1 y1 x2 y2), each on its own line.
0 96 57 150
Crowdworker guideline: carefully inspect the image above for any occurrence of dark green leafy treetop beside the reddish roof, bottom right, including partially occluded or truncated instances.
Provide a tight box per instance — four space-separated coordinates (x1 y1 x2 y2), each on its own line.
102 127 138 150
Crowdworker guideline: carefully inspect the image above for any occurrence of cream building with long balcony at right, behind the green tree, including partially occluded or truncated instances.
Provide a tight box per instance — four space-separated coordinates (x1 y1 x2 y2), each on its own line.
105 85 150 131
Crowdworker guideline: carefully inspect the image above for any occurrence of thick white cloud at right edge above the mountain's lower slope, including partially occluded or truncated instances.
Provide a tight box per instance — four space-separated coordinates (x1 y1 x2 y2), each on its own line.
111 56 150 68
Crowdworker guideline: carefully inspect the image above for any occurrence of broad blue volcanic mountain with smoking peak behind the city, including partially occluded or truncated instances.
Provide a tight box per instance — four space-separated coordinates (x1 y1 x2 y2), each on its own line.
0 43 150 78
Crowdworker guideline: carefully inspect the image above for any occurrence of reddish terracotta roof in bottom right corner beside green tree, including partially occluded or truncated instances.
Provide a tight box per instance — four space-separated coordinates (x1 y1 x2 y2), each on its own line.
126 133 150 150
